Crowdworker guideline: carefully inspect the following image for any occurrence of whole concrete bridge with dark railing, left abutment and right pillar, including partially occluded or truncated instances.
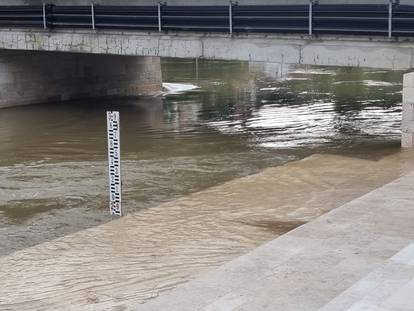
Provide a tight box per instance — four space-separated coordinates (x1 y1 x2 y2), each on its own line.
0 0 414 146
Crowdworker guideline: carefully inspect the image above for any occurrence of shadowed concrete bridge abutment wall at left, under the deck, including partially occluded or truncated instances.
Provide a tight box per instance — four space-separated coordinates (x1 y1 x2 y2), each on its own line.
0 50 162 108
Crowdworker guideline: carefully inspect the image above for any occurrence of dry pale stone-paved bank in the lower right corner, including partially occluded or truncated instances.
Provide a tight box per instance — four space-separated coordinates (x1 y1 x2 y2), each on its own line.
142 165 414 311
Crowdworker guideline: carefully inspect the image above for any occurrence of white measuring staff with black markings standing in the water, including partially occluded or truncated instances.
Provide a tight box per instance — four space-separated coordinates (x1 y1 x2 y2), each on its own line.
106 111 122 216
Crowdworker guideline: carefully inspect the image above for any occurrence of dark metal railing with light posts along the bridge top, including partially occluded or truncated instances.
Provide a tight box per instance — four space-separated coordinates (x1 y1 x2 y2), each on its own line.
0 0 414 37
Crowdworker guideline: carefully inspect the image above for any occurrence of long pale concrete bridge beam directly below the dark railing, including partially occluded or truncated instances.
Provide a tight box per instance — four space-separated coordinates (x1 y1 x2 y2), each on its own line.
0 29 414 70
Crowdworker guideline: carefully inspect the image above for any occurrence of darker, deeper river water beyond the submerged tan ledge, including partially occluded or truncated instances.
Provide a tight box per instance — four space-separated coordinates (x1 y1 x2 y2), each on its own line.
0 59 408 255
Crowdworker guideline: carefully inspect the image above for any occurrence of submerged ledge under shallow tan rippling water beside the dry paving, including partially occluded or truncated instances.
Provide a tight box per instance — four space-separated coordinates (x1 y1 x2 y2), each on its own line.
0 151 414 310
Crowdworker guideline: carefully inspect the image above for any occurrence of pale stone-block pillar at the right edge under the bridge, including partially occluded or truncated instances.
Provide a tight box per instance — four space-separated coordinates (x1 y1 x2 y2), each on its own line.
401 72 414 148
